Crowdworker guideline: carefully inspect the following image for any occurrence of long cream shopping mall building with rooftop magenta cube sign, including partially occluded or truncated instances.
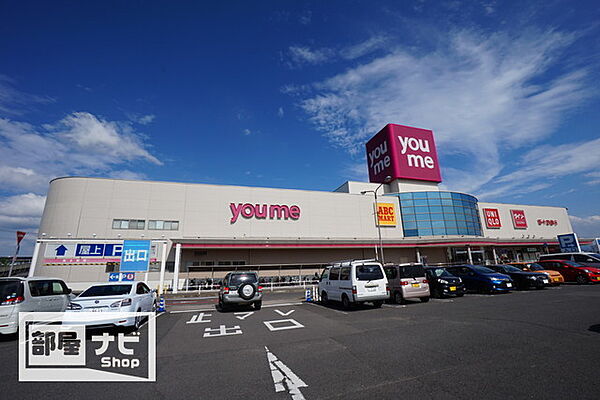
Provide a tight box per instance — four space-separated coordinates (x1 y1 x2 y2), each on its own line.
34 124 572 289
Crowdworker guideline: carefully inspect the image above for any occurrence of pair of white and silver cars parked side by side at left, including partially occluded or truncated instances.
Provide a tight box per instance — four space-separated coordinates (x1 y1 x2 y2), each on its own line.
0 277 156 334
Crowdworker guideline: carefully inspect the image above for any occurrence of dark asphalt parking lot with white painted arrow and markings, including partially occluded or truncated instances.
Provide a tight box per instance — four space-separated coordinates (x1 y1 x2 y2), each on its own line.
0 285 600 399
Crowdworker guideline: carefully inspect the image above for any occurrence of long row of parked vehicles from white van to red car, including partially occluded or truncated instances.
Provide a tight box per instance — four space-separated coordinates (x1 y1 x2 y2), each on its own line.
318 255 600 308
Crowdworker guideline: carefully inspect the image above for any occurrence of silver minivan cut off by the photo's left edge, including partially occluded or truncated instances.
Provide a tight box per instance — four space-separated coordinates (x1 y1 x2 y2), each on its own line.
0 277 71 334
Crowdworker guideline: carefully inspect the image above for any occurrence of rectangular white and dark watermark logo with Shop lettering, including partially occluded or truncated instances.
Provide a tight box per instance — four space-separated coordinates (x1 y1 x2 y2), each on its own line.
19 312 156 382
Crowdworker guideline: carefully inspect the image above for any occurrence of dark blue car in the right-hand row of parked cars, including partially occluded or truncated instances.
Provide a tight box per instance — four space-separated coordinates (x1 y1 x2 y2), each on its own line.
446 265 515 293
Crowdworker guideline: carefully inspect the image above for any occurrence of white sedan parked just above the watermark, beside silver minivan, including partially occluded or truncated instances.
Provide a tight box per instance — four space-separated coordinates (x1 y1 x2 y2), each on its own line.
67 282 156 329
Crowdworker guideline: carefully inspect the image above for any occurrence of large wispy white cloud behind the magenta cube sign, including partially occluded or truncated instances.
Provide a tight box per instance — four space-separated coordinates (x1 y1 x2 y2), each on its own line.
300 31 590 192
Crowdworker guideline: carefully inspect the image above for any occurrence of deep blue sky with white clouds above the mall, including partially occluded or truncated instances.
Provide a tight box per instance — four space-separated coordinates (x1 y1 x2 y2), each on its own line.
0 1 600 255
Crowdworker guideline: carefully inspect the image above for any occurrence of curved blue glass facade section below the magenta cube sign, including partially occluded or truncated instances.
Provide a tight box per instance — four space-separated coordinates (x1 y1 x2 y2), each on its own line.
397 192 481 237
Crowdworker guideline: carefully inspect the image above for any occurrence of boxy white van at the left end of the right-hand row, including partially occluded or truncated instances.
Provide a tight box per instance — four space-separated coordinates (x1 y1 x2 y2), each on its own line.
319 260 390 308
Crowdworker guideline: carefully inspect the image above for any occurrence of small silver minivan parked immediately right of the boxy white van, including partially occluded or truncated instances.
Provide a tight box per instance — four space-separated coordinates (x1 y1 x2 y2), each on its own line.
383 264 431 304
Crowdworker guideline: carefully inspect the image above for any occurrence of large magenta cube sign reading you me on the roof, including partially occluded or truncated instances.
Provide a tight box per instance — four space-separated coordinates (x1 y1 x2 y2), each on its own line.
366 124 442 183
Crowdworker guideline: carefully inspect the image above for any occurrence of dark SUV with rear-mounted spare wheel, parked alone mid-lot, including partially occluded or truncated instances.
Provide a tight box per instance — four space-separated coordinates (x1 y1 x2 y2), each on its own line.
219 271 262 310
